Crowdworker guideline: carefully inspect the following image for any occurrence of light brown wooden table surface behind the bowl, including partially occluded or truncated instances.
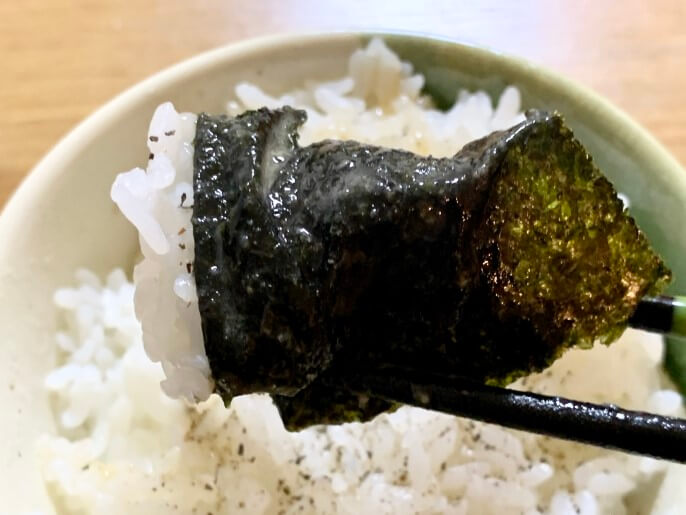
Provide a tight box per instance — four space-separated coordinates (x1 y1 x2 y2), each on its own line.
0 0 686 205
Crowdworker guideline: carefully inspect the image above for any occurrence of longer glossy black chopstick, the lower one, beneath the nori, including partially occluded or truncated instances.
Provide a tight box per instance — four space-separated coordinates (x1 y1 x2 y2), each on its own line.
346 371 686 463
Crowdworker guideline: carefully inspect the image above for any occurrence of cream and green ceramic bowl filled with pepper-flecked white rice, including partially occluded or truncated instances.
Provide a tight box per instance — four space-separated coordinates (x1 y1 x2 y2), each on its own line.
0 33 686 515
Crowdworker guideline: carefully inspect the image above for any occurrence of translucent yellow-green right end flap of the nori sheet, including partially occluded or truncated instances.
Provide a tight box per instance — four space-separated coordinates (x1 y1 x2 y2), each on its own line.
481 117 671 347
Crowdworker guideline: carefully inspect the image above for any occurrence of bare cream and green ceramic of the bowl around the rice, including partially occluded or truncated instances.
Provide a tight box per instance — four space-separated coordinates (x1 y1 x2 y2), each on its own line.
0 33 686 512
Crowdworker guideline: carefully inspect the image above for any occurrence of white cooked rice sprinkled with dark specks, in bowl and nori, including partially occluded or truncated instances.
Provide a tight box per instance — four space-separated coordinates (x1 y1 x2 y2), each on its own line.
38 41 683 515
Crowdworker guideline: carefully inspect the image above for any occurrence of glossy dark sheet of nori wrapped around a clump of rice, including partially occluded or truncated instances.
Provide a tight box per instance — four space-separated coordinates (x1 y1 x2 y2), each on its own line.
193 107 670 428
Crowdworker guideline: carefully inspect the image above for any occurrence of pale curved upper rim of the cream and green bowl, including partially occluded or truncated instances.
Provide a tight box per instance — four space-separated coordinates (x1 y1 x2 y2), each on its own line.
0 30 686 228
